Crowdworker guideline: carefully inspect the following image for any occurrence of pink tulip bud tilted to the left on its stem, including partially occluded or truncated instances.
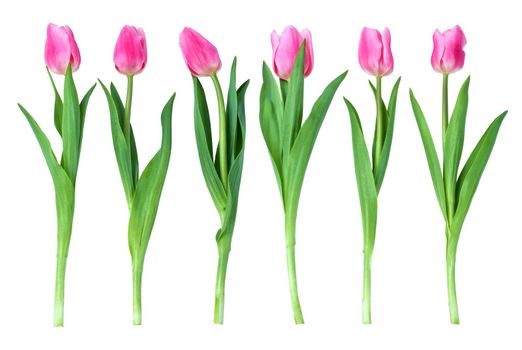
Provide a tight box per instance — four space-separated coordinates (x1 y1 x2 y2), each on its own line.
179 27 221 77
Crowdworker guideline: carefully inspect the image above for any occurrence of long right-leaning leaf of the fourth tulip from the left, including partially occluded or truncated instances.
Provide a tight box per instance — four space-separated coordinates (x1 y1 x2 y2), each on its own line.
283 71 348 211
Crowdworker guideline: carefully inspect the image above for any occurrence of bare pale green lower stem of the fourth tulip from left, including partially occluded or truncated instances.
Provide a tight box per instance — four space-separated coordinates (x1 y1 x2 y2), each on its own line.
285 211 304 324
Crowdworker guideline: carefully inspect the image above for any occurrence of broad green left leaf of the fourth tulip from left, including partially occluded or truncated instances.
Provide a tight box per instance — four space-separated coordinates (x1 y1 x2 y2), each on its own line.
259 62 284 196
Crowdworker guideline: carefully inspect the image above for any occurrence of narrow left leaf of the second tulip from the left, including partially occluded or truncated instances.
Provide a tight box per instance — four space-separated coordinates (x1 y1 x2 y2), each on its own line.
98 80 135 209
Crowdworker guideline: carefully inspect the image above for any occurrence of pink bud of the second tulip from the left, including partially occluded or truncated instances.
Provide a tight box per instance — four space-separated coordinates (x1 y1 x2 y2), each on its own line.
114 25 147 76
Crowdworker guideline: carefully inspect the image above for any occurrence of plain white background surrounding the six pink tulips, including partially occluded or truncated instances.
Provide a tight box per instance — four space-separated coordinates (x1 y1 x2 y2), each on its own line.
0 0 522 349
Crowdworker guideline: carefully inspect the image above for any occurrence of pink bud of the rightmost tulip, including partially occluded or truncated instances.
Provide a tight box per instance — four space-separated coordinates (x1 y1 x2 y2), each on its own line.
431 25 466 74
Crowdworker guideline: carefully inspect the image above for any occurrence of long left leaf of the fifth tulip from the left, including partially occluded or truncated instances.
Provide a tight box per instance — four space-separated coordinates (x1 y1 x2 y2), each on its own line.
344 98 377 256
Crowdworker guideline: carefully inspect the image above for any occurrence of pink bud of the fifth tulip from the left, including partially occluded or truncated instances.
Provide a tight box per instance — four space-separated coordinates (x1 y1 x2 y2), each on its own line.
359 27 393 77
